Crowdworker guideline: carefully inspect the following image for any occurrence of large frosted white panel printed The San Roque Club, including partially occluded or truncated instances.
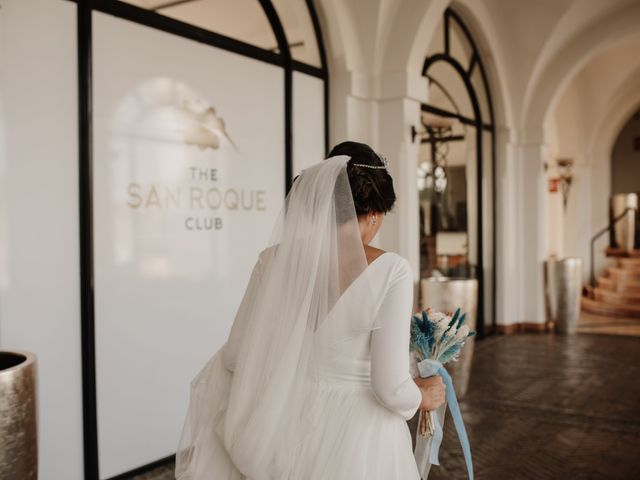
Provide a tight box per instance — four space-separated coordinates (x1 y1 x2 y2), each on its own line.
93 13 284 478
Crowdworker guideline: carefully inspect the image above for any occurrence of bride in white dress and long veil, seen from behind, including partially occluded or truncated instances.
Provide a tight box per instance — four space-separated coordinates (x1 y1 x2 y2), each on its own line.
175 142 444 480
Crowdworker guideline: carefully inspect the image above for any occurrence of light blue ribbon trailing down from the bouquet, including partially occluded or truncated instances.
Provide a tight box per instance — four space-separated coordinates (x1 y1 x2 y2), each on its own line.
418 358 473 480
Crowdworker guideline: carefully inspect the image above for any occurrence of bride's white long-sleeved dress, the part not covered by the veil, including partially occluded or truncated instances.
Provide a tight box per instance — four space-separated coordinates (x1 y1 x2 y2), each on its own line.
288 252 421 480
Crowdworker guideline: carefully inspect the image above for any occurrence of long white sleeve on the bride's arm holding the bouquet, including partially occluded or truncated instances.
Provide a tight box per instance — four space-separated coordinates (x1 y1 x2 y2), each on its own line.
371 260 422 420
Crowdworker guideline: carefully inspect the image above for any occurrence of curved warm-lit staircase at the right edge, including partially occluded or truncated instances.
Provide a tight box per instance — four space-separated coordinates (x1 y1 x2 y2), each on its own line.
582 250 640 318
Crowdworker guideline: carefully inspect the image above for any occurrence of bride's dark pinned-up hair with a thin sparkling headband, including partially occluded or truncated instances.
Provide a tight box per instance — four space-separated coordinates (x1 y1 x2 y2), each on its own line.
329 142 396 215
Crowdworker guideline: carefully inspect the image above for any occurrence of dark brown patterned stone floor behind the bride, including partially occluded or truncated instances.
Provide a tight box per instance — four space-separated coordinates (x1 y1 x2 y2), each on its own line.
137 333 640 480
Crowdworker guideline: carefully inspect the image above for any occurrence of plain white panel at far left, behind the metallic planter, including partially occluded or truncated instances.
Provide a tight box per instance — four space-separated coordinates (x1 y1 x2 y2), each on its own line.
0 0 83 480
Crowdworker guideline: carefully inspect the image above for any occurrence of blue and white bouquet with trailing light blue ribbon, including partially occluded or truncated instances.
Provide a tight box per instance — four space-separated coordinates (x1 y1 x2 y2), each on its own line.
410 308 476 478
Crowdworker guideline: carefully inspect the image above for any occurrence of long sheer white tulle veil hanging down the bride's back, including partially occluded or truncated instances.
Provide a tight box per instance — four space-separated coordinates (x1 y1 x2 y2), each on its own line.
176 156 375 480
